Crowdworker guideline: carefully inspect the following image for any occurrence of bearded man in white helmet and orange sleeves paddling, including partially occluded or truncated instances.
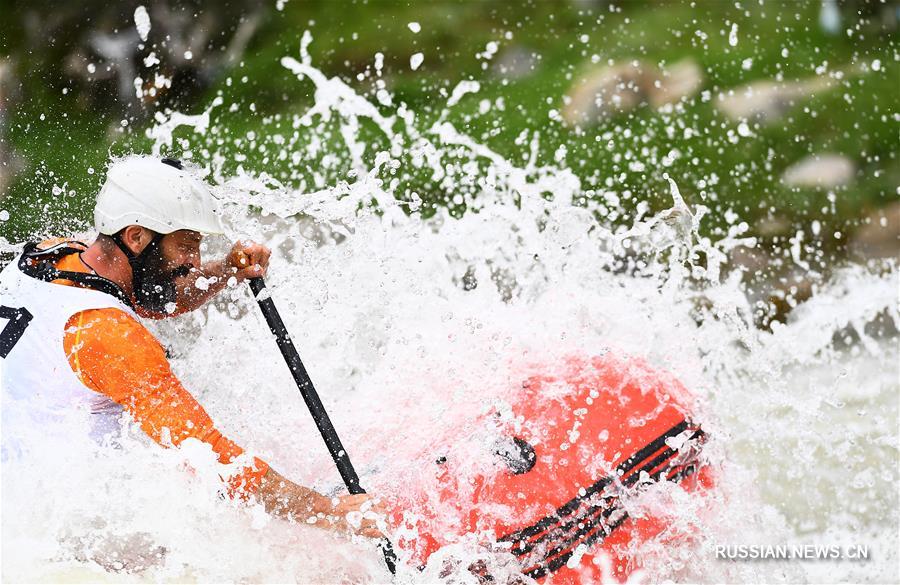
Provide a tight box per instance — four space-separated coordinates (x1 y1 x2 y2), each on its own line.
0 156 381 537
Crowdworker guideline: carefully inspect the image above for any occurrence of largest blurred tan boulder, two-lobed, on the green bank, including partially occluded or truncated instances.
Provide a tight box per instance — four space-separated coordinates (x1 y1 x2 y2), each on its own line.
562 60 703 126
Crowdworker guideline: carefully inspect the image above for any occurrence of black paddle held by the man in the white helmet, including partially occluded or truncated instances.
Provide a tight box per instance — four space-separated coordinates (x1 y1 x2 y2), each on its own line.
250 278 397 573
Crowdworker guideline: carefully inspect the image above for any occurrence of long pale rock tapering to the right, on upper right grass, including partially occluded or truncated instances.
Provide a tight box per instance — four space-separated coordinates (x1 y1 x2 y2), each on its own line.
716 77 835 124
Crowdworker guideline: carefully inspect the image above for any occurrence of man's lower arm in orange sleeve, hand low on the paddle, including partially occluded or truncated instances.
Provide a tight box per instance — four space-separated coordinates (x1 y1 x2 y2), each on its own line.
63 309 381 536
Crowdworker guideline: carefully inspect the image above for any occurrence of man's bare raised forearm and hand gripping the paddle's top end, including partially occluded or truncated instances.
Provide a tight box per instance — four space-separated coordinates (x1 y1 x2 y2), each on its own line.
175 241 272 315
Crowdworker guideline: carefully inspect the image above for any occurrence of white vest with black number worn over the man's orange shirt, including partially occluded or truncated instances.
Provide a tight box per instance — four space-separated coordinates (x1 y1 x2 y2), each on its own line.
0 248 135 448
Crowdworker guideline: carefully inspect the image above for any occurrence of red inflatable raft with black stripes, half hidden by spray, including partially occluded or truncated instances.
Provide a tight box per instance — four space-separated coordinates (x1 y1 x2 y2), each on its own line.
397 354 712 583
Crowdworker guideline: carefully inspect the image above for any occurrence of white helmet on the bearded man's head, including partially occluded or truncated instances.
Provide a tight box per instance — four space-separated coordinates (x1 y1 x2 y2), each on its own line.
94 155 225 236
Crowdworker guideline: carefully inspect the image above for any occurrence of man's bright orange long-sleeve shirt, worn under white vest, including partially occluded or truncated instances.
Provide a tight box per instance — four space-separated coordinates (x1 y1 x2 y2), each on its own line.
54 244 269 497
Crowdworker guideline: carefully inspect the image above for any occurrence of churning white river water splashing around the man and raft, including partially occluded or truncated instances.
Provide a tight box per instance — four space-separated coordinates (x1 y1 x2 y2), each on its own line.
2 33 900 583
